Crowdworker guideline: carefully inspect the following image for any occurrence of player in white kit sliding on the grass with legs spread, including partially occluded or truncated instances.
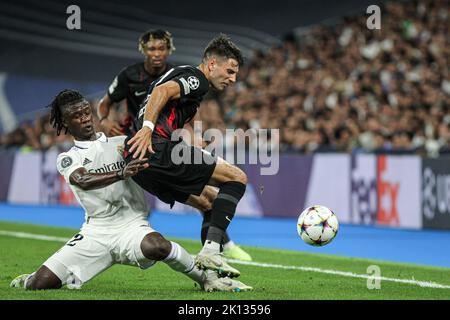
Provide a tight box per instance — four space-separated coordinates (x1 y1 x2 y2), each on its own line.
11 90 252 291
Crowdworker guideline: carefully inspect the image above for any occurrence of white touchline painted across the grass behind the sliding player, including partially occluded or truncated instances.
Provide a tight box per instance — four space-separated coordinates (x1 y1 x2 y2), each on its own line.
0 230 450 289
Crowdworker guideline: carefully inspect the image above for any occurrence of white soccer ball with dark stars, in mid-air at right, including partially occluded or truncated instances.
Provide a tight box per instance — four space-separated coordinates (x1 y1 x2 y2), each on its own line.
297 205 339 246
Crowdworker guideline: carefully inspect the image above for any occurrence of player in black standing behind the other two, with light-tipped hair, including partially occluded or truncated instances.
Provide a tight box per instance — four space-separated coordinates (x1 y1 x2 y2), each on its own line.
97 29 252 261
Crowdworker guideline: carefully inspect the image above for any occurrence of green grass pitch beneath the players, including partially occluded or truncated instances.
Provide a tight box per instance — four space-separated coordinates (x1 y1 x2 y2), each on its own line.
0 222 450 300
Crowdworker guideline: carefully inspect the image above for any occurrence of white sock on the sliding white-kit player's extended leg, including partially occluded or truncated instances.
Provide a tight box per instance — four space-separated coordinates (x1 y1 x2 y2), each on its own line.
163 241 206 284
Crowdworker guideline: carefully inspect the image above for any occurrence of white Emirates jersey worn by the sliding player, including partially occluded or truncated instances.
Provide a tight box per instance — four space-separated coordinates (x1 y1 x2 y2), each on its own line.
56 132 149 224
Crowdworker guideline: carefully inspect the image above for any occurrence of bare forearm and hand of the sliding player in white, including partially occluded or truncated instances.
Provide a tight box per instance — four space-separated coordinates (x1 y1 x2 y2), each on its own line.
69 159 148 190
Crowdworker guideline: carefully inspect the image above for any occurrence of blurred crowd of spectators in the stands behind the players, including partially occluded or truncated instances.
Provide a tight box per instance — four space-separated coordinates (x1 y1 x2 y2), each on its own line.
0 1 450 157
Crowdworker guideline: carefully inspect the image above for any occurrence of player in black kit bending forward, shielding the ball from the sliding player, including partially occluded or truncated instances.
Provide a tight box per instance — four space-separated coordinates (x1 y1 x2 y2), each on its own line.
124 35 247 277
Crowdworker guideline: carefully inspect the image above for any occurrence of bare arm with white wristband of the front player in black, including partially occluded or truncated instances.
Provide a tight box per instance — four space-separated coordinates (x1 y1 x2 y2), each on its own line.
128 81 181 159
